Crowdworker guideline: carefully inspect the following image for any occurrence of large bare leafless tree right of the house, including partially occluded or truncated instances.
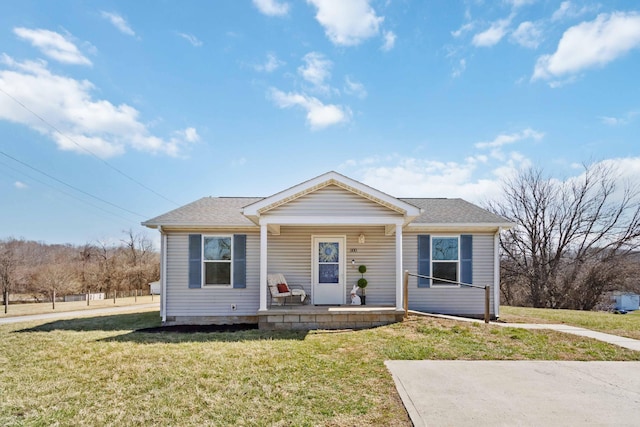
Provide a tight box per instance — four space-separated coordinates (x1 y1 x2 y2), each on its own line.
488 163 640 310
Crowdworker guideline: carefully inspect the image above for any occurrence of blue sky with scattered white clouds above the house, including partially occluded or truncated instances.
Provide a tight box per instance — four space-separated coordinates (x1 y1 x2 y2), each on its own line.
0 0 640 244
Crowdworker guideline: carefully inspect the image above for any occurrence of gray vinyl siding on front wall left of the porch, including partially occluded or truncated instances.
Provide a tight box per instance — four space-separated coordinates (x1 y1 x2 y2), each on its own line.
166 232 260 316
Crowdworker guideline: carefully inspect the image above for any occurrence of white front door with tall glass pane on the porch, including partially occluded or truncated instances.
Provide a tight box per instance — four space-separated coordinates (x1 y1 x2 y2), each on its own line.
311 236 346 305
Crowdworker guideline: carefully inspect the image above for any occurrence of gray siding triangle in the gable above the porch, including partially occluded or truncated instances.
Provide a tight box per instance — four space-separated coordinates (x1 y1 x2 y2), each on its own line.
268 185 399 217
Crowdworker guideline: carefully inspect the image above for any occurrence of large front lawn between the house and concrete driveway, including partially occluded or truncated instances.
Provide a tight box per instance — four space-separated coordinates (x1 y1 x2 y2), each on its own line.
0 312 640 426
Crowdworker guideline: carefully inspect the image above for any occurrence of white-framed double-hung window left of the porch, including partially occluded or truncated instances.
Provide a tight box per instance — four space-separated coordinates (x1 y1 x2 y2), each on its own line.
202 236 233 286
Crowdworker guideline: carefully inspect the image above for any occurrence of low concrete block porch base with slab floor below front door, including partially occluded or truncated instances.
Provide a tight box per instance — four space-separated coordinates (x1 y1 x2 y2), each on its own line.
258 305 404 330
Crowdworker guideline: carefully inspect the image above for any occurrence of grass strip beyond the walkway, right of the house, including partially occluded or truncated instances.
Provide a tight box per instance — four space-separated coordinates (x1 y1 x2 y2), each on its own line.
500 306 640 339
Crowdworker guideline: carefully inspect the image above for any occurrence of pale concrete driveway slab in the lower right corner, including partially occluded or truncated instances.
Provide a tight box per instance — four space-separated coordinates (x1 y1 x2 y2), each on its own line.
385 360 640 427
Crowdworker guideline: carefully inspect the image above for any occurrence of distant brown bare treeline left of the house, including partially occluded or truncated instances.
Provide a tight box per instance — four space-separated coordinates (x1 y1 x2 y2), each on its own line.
0 231 160 302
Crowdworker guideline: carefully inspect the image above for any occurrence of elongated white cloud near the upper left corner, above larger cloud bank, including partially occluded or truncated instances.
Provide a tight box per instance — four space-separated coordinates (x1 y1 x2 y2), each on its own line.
13 27 91 65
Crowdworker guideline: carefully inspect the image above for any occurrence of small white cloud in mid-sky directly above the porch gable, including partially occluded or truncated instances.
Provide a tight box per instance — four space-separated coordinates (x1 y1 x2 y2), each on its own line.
269 88 351 130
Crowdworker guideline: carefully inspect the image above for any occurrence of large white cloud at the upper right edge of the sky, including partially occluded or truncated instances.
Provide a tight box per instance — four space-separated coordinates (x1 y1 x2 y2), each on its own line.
531 12 640 80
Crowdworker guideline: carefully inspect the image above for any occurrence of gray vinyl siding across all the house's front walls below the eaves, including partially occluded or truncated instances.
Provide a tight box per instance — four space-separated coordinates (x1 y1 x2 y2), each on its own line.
165 226 494 316
